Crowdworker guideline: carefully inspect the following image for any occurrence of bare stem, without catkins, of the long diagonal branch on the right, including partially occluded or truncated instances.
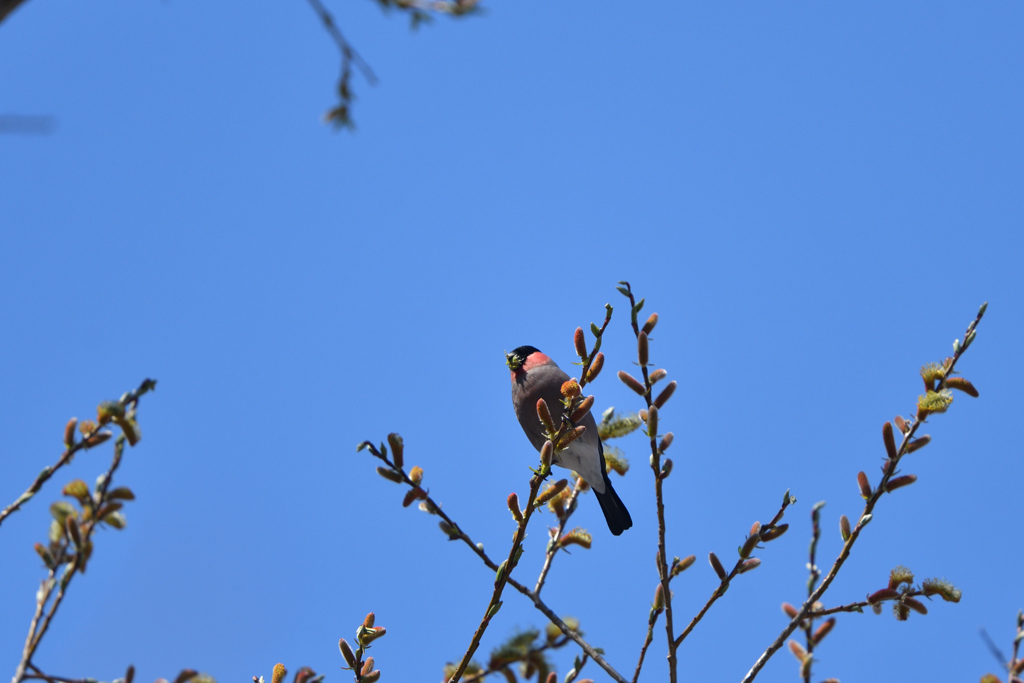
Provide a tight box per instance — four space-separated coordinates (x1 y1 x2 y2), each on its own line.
742 305 985 683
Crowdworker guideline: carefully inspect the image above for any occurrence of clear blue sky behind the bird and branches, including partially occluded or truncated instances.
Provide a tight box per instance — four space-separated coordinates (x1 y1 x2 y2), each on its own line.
0 0 1024 683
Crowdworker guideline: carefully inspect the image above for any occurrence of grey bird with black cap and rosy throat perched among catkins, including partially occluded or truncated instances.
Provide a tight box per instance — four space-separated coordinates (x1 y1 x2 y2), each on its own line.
505 346 633 536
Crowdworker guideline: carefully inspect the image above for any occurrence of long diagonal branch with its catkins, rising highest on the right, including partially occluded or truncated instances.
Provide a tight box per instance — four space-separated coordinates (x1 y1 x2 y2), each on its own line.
742 302 988 683
